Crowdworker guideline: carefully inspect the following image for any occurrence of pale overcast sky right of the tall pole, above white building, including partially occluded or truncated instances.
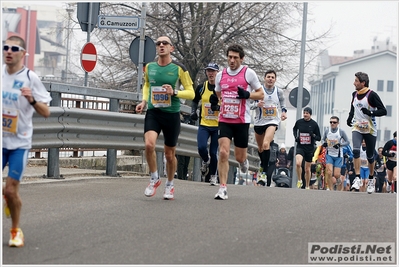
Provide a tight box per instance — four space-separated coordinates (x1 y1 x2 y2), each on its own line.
307 1 398 56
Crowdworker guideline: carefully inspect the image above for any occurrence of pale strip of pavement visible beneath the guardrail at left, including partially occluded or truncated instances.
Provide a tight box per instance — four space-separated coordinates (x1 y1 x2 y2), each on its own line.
2 164 148 183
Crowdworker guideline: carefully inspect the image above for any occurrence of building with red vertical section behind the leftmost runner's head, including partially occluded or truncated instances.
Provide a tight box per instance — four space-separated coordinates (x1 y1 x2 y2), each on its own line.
2 2 69 77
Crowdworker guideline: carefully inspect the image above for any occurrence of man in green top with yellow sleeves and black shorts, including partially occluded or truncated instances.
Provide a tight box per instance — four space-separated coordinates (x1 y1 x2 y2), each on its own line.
136 36 195 199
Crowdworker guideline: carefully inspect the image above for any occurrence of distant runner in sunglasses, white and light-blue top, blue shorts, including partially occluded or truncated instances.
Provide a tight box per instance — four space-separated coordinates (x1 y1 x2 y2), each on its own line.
322 116 349 190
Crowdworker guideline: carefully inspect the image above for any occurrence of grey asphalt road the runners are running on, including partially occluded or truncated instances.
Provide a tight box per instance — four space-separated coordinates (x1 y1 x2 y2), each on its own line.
2 178 397 265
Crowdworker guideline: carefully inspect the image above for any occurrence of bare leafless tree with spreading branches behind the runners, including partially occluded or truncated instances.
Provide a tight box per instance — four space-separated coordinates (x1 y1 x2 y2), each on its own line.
83 2 329 91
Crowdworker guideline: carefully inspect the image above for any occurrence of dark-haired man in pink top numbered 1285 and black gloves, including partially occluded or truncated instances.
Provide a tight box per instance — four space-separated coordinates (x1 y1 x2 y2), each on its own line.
209 44 264 199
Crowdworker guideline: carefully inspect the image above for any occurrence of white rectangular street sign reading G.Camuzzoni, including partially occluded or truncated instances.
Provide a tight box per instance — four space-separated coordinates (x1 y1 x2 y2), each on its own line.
98 15 140 30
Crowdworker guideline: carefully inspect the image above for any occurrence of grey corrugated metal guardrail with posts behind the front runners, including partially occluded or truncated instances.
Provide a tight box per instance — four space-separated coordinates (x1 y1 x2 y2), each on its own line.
32 83 259 181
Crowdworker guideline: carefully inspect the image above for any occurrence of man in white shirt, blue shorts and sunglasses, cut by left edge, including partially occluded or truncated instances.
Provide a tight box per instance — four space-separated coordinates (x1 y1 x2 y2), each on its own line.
2 36 51 247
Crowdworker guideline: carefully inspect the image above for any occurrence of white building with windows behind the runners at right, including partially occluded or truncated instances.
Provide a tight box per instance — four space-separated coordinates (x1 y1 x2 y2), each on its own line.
309 44 398 147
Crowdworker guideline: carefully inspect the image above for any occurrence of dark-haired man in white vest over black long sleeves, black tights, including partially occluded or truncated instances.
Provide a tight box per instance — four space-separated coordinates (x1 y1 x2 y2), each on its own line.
346 72 387 194
